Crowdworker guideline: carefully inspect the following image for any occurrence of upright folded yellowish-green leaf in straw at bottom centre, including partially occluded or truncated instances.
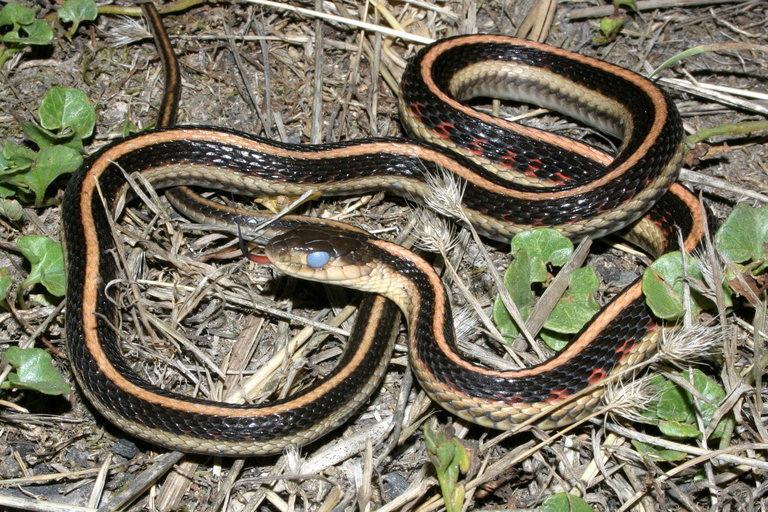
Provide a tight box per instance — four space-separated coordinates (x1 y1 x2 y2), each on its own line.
424 420 469 512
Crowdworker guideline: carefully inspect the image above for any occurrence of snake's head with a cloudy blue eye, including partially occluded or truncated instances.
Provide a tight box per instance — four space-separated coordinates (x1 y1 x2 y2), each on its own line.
264 226 376 291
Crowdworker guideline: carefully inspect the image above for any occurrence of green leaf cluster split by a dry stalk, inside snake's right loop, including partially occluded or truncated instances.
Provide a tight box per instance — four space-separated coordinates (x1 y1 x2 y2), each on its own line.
493 229 600 350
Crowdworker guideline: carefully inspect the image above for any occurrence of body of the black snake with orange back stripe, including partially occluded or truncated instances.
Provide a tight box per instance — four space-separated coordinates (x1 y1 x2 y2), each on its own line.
62 5 701 456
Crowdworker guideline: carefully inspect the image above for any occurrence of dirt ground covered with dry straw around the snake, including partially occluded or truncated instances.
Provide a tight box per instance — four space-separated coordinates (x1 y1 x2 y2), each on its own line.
0 0 768 511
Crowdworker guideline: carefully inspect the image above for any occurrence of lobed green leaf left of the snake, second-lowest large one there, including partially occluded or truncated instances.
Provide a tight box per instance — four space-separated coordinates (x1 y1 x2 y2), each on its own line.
16 236 65 297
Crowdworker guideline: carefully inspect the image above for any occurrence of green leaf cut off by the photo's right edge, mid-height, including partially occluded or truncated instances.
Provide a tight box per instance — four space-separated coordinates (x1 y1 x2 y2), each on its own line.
715 203 768 263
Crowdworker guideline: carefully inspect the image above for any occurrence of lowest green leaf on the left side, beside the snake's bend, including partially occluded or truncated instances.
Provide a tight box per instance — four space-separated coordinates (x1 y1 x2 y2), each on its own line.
2 347 70 395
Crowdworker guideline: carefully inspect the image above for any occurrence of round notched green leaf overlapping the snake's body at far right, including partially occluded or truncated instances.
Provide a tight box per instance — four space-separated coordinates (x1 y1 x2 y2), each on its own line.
643 251 712 320
